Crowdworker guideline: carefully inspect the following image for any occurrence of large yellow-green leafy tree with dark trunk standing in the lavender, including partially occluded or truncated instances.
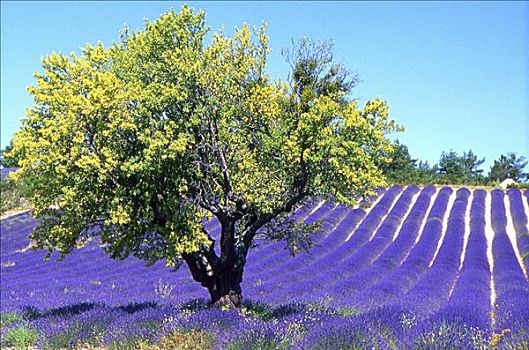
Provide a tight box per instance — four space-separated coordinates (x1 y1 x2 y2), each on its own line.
10 6 398 308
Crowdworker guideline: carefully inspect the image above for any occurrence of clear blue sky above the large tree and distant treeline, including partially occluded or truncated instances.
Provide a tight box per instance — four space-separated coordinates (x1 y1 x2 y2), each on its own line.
1 2 529 171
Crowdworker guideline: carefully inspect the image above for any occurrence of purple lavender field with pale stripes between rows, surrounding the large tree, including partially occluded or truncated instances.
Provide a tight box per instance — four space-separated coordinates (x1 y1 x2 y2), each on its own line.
0 186 529 349
